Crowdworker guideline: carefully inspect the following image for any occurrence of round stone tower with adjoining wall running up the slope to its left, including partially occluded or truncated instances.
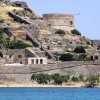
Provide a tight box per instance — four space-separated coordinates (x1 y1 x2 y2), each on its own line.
9 9 74 34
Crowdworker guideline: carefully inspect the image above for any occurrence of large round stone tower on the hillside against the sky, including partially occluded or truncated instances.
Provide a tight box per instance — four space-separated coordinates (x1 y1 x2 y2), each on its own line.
43 14 74 31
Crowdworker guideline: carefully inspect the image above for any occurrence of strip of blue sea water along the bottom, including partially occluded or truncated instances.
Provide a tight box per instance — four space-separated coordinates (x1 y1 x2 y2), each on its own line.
0 88 100 100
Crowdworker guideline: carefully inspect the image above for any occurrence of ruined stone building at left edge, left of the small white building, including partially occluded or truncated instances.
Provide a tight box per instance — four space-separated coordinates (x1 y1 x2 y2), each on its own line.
0 49 26 64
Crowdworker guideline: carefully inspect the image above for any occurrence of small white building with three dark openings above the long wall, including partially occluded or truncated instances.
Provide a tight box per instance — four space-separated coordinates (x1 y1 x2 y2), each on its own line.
28 57 47 65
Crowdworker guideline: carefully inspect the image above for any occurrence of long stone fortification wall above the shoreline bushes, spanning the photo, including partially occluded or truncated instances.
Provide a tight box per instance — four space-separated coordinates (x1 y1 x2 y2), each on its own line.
0 62 100 82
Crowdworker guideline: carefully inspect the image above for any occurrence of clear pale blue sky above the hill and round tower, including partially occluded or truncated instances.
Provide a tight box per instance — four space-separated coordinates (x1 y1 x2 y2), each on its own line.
13 0 100 39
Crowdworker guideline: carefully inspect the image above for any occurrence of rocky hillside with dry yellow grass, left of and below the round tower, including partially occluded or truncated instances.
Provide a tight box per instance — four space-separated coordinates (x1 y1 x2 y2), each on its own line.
0 0 98 60
